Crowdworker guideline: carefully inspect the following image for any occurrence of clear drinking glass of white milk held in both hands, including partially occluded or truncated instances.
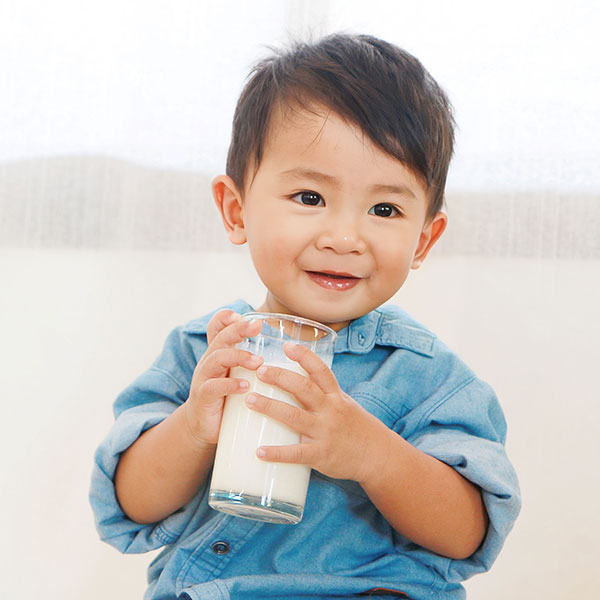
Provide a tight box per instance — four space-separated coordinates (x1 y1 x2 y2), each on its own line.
208 313 337 524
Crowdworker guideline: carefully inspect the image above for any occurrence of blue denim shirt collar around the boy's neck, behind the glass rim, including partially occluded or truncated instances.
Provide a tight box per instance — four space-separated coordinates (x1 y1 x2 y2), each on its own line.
183 300 436 357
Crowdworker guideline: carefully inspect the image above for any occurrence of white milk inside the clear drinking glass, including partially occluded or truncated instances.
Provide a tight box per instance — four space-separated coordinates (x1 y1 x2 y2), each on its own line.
210 363 310 508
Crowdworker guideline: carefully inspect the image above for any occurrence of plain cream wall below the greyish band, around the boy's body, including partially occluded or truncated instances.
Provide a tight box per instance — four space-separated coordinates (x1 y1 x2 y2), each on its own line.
0 243 600 600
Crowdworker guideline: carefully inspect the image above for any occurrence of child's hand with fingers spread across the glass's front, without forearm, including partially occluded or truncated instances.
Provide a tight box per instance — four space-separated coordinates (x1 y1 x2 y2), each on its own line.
247 343 387 483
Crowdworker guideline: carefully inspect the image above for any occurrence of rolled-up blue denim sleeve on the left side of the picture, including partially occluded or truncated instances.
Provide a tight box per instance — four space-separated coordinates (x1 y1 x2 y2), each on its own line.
90 328 205 553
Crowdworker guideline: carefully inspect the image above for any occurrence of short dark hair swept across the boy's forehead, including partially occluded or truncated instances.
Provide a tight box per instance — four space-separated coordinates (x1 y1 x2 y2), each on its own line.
226 34 454 216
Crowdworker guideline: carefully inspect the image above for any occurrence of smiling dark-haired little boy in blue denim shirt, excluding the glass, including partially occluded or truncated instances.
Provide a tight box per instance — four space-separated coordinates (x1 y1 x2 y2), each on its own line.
91 35 520 600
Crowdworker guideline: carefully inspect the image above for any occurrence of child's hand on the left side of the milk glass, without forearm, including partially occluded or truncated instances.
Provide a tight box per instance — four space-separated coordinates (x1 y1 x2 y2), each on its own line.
182 310 263 446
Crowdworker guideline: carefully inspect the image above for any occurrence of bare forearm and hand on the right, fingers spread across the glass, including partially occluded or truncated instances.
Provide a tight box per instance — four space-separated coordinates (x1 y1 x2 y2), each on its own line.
249 346 487 558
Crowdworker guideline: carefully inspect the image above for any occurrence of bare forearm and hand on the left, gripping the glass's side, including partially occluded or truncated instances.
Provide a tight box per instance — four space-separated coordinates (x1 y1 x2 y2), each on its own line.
115 311 261 523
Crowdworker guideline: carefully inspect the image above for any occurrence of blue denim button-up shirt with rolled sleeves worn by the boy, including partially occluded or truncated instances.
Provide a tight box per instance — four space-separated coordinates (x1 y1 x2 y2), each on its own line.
90 300 521 600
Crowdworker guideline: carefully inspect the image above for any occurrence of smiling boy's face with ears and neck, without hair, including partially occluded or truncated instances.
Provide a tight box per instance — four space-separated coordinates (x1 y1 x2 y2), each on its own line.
213 103 446 330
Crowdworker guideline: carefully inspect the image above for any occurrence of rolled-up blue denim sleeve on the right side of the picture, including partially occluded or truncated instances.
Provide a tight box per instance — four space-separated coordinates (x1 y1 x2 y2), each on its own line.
407 378 521 583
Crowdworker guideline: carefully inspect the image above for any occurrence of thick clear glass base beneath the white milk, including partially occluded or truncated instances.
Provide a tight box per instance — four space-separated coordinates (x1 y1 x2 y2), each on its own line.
208 490 304 525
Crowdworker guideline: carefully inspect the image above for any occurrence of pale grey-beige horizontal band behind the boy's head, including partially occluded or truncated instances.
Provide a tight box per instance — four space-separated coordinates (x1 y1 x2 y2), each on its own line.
0 156 600 259
